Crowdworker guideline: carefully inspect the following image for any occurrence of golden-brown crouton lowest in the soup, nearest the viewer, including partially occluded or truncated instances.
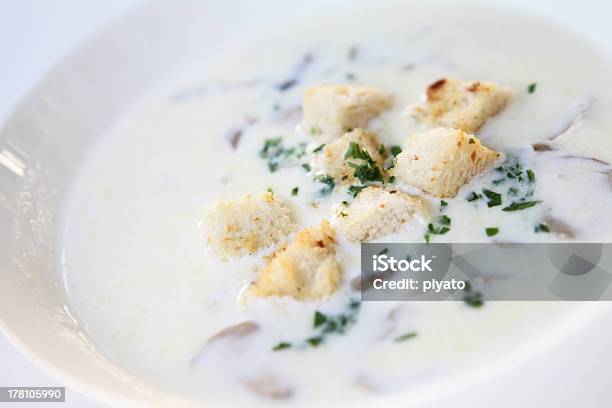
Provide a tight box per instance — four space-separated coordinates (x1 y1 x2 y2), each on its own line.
247 221 342 300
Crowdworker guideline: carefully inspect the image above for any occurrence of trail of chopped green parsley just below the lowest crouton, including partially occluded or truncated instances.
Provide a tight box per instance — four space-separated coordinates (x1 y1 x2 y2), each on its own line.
272 299 361 351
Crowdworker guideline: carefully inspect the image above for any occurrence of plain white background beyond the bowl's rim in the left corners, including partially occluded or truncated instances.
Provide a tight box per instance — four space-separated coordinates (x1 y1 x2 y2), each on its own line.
0 0 144 408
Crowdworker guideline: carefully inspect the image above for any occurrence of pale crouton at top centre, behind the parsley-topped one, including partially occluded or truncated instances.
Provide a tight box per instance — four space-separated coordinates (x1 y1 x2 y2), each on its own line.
303 85 393 141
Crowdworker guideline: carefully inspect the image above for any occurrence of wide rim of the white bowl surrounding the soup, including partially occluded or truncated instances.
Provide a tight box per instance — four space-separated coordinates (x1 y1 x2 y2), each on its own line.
0 0 612 407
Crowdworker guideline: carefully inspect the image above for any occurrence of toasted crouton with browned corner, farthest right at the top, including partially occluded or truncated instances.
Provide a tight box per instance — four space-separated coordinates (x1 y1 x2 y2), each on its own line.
412 78 512 133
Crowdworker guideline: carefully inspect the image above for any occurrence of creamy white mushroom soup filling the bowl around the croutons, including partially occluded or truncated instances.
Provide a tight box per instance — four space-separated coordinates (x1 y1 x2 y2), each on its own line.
61 5 612 406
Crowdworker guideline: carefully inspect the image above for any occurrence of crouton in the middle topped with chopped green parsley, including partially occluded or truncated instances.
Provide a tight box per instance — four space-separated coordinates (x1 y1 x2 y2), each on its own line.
313 129 384 184
